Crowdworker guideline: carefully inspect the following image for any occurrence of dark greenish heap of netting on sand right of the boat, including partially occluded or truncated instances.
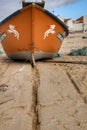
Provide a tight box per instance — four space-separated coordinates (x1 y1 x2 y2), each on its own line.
68 47 87 56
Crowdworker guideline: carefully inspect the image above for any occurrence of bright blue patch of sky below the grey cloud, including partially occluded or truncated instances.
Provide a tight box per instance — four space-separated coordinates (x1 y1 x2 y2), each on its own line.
50 0 87 20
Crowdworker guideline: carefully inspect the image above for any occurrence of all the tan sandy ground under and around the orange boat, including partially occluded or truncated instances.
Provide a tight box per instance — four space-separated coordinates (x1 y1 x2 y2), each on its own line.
0 33 87 130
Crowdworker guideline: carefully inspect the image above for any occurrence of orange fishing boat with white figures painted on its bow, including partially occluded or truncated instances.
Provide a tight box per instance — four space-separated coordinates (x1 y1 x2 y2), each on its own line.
0 0 68 65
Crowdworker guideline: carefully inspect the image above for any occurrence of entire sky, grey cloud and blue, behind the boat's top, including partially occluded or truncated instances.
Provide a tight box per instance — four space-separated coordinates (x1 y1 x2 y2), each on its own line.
0 0 87 21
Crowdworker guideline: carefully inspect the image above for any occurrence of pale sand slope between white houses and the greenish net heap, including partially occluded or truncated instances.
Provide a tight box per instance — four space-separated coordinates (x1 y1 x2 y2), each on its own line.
59 33 87 54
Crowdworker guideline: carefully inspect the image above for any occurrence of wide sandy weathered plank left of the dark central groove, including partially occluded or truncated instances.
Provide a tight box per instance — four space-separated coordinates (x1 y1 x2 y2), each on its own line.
0 62 33 130
